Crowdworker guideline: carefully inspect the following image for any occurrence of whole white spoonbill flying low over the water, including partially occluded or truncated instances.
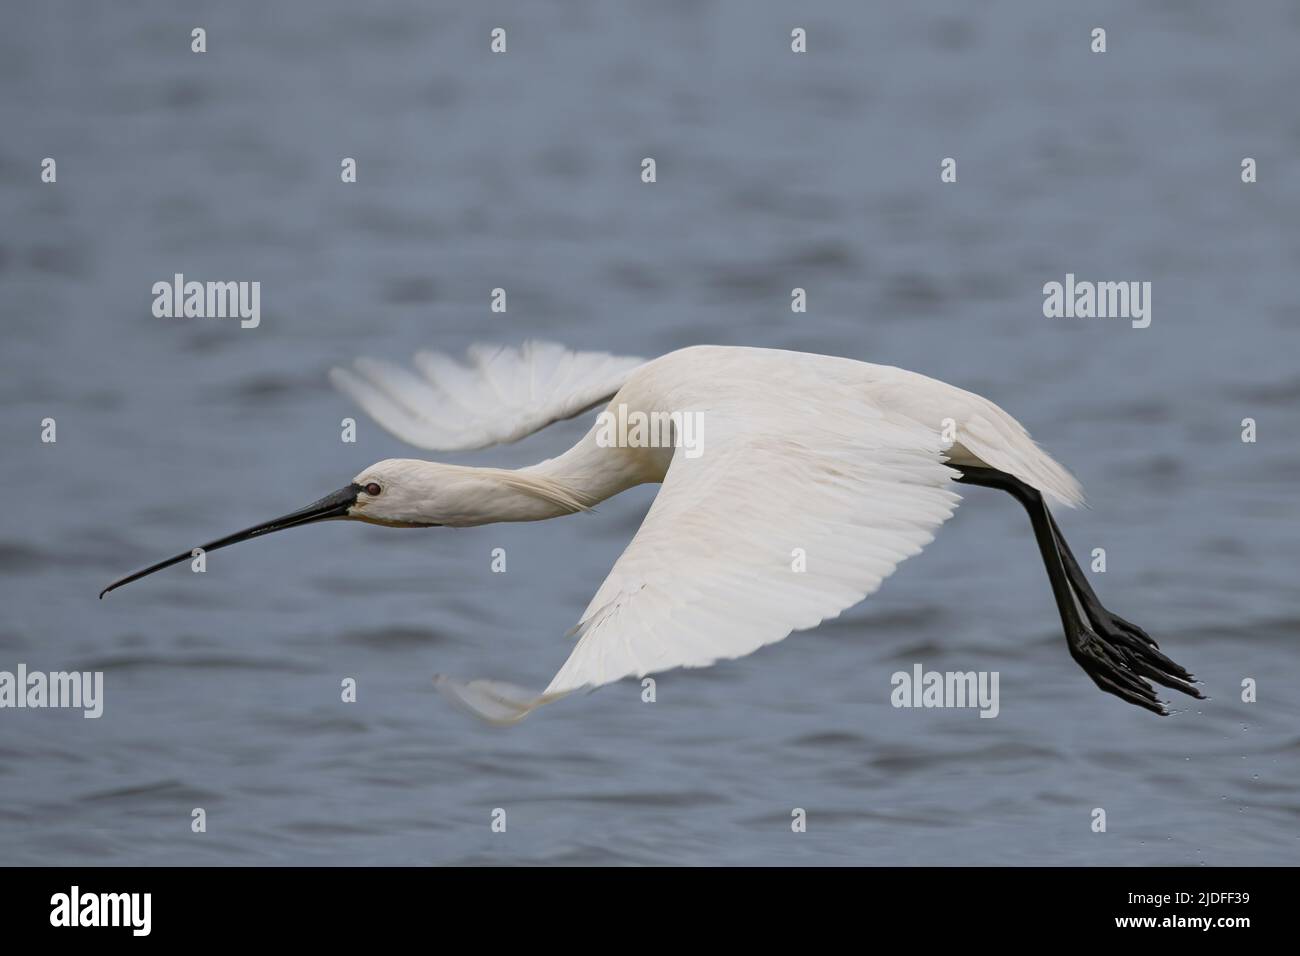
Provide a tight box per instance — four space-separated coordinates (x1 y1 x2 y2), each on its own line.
100 342 1201 723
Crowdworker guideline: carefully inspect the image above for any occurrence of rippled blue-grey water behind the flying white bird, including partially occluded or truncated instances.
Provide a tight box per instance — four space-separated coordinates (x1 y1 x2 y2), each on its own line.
0 0 1300 866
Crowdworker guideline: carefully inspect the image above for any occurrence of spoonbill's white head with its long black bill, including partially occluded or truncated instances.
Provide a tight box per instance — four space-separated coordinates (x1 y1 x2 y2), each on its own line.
99 458 450 598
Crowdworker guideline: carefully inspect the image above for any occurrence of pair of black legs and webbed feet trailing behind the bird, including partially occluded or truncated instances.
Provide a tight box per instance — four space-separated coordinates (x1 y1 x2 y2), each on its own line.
953 466 1201 714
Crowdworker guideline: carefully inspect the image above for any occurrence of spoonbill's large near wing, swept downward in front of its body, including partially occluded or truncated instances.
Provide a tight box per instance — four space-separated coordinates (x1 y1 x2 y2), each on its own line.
436 399 959 723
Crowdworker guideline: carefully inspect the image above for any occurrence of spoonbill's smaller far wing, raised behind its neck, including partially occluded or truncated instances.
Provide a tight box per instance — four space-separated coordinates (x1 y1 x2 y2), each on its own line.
330 342 645 451
